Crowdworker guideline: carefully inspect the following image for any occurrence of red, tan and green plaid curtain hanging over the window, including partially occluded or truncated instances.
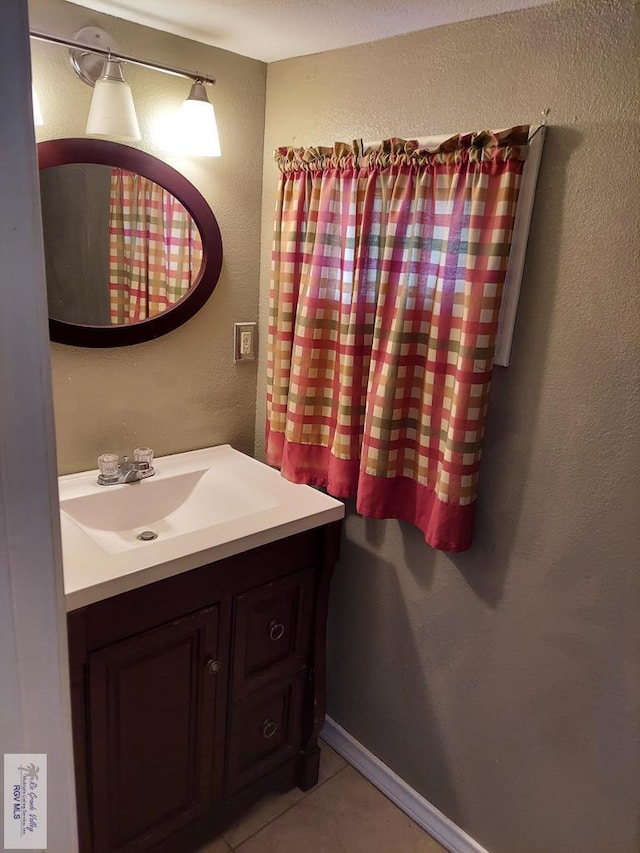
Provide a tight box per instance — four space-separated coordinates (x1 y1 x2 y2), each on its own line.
266 126 529 551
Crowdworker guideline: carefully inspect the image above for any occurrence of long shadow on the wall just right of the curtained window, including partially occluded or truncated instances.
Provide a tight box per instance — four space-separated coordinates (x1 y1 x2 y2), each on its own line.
400 127 581 607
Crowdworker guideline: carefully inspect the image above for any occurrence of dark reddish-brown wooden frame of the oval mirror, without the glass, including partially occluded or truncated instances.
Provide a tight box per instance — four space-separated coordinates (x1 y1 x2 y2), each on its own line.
38 139 222 347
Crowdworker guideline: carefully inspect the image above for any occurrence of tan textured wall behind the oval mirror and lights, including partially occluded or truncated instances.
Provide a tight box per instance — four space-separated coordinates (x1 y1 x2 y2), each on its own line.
29 0 266 473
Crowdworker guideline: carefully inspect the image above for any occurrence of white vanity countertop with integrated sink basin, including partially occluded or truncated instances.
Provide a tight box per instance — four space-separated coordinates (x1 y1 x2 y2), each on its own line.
58 445 344 611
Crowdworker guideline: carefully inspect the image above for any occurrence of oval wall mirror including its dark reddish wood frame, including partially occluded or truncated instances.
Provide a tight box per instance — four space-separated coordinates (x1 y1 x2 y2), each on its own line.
38 139 222 347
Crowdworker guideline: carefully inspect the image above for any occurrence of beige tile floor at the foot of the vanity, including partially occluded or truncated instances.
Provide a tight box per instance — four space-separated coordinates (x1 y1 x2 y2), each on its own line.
200 744 447 853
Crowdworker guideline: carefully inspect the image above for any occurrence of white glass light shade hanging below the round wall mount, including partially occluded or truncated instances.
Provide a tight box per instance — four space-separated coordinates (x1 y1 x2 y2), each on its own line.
87 59 141 142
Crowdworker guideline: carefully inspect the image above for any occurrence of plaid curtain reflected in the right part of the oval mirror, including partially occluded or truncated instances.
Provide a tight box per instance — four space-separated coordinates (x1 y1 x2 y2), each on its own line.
109 168 202 324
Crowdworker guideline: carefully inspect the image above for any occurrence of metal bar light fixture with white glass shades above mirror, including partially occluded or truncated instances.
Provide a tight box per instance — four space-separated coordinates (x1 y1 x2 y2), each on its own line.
30 27 220 157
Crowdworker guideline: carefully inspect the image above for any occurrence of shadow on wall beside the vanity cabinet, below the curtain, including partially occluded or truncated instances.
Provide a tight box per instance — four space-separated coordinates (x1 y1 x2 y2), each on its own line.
327 516 458 819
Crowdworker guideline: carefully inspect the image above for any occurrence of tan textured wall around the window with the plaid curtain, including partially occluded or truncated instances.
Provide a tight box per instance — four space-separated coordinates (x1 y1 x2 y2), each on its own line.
257 0 640 853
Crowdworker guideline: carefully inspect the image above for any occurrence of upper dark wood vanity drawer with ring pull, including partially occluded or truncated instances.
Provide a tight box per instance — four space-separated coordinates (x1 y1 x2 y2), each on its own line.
233 569 314 697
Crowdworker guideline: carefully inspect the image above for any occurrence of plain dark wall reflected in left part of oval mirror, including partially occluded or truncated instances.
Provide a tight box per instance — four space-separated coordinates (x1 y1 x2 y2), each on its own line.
40 163 110 326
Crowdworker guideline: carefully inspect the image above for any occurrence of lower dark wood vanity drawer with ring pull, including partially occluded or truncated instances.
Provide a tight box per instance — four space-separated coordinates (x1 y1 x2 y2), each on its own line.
226 672 305 796
